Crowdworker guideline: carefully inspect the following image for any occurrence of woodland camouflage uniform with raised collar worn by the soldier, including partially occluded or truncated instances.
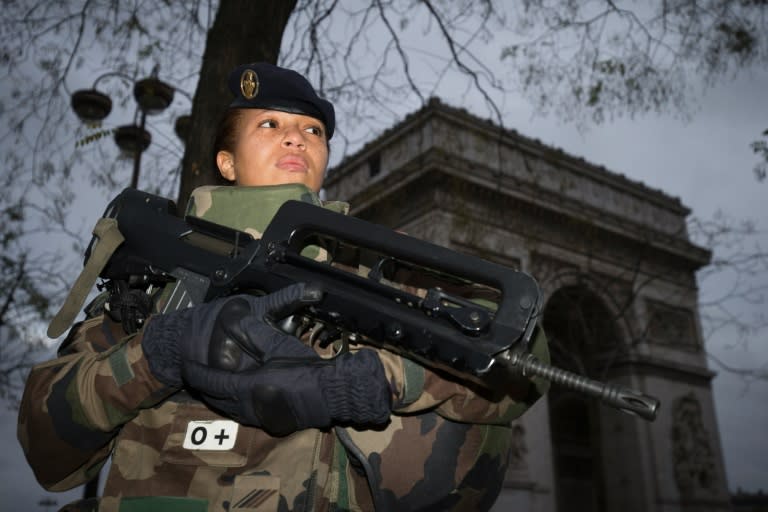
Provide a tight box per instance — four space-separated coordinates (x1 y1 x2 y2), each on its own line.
18 186 548 512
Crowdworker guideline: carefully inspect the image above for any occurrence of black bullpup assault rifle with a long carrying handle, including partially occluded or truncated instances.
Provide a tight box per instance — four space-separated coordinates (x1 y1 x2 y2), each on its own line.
49 188 659 420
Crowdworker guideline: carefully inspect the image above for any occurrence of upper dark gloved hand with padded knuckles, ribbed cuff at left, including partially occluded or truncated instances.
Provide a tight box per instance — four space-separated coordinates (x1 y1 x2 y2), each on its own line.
141 283 321 387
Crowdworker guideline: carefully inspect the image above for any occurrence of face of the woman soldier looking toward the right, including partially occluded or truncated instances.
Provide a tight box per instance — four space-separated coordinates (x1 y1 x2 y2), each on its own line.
216 109 328 192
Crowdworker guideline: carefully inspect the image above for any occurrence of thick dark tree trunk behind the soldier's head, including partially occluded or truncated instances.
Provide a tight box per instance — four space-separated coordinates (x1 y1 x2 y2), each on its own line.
177 0 296 212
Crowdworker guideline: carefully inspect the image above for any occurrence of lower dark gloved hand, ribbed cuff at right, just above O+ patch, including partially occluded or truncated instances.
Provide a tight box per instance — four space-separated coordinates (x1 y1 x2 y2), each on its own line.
183 315 391 436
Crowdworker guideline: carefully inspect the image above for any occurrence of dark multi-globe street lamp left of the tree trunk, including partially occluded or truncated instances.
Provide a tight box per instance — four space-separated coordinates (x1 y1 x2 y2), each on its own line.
72 67 189 188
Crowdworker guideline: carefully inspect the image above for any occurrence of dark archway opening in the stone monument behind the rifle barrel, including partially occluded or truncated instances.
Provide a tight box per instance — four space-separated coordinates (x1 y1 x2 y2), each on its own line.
542 280 621 512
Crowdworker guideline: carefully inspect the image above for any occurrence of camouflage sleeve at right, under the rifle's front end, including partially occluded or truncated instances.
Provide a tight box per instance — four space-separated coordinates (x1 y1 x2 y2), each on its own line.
379 329 549 425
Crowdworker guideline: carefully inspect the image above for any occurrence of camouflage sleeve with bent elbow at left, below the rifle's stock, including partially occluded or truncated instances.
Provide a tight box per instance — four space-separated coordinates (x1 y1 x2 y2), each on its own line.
18 316 172 491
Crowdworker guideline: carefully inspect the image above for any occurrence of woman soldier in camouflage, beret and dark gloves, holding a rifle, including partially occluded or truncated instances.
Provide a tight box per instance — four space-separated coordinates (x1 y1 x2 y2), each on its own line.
18 63 546 511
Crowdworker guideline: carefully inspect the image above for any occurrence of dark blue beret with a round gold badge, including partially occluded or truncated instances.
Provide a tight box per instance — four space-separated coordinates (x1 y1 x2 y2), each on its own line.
228 62 336 139
